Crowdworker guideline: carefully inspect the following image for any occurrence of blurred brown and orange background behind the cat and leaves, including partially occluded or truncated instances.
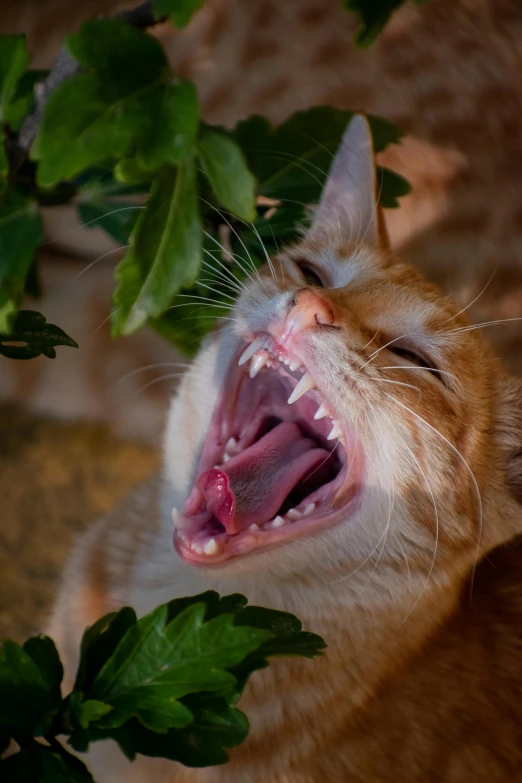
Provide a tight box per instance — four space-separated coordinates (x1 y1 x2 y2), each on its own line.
0 0 522 639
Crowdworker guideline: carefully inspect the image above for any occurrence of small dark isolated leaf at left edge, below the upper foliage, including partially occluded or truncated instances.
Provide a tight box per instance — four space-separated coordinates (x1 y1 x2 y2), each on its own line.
0 310 78 359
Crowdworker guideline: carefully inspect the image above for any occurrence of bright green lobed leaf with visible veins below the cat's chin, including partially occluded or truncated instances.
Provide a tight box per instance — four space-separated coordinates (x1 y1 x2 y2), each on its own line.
91 604 270 732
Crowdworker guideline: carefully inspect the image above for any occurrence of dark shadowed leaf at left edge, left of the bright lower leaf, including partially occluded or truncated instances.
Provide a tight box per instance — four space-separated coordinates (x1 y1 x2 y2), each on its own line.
0 639 61 736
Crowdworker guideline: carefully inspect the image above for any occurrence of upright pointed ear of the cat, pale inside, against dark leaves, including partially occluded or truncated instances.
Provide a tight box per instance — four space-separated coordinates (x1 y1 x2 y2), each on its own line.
309 114 382 245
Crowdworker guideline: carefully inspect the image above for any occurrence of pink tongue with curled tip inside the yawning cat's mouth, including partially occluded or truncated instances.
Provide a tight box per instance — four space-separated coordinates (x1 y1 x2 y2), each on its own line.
198 422 329 535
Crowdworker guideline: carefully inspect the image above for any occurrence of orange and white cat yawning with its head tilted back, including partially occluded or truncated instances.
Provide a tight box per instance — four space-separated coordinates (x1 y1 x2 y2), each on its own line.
50 115 522 783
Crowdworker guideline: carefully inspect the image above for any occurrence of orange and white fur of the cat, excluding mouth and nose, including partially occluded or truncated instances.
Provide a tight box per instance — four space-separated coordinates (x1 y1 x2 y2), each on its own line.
50 120 522 783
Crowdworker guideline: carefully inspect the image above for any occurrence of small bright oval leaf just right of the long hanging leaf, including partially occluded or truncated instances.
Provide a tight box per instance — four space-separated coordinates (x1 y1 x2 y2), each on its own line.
197 127 257 222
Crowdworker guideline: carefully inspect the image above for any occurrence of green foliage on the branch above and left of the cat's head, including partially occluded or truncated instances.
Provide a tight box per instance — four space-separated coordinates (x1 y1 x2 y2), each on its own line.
0 0 409 358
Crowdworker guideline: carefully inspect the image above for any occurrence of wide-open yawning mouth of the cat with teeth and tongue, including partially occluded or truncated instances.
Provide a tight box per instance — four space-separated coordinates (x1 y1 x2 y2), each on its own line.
173 334 362 566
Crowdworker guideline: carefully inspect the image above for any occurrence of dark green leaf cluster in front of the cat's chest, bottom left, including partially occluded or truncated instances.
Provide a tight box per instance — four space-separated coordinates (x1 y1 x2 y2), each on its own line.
0 591 326 783
